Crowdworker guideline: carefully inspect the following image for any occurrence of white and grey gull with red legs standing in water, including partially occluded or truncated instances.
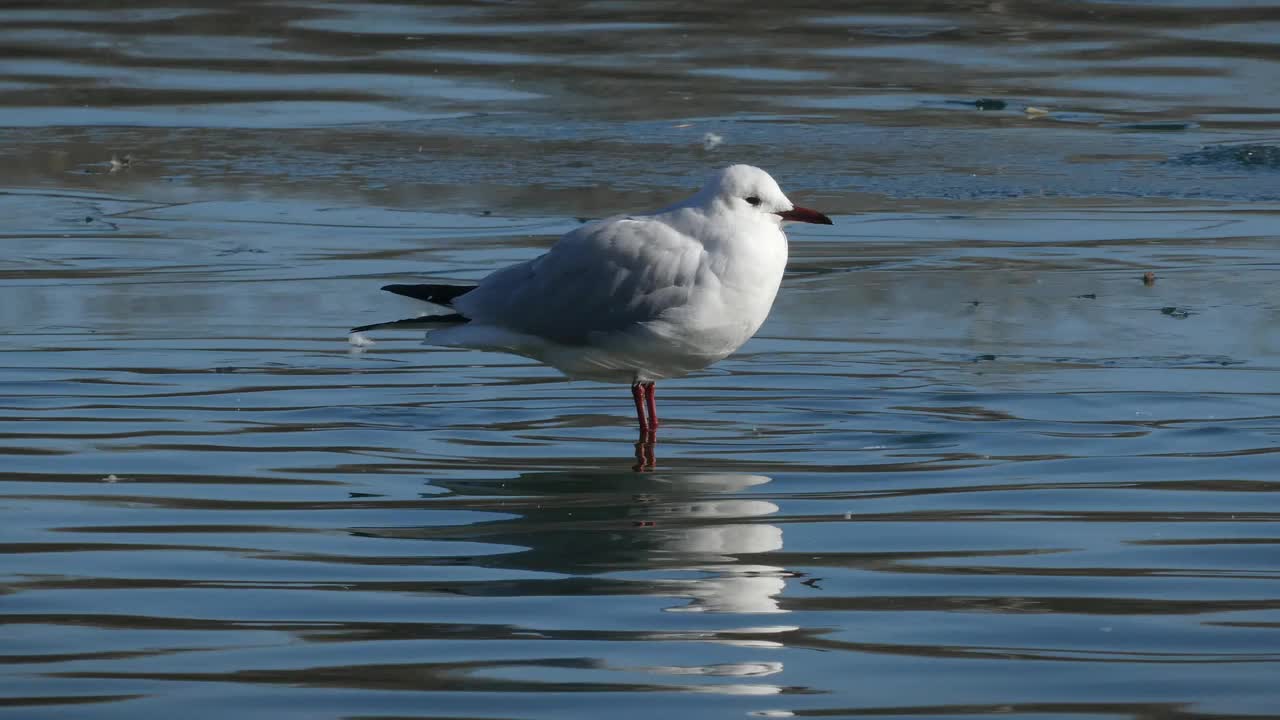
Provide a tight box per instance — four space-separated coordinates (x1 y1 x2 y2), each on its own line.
351 165 831 441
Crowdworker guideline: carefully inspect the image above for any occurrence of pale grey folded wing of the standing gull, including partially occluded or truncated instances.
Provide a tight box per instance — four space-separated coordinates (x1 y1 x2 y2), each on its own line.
454 218 708 345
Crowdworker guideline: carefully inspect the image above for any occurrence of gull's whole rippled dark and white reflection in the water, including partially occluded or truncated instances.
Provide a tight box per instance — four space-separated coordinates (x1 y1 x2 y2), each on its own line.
350 470 799 696
